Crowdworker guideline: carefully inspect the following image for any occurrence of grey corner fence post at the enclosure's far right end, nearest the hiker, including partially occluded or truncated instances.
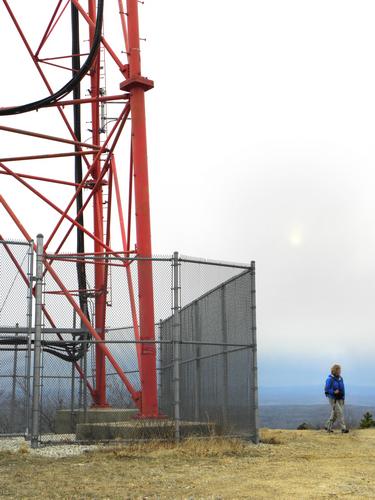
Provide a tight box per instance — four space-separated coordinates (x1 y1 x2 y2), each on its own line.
250 261 259 444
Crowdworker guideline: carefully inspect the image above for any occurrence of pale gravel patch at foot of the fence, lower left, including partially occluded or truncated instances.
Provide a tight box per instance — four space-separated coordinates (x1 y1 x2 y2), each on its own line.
0 435 100 458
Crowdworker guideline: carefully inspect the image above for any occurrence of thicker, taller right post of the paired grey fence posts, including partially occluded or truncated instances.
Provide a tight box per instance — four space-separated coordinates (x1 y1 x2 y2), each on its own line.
31 234 43 448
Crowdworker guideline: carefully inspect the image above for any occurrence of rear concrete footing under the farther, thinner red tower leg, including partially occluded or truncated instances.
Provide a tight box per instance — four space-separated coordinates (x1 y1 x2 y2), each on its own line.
55 408 138 434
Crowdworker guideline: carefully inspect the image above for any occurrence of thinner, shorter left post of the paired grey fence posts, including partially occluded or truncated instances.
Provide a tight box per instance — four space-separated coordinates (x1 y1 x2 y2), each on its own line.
25 241 34 439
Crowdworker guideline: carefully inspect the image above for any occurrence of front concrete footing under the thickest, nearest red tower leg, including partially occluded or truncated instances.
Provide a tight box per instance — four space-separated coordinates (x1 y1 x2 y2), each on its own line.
77 420 218 441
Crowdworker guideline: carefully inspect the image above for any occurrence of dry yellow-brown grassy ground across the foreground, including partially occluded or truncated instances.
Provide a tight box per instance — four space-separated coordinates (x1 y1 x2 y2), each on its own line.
0 429 375 499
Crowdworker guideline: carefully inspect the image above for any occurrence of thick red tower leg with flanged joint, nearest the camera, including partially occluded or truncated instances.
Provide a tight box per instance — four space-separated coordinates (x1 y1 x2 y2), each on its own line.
121 0 158 417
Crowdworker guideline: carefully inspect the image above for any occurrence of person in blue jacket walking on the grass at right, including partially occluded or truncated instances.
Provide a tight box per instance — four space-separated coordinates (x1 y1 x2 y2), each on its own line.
324 365 349 434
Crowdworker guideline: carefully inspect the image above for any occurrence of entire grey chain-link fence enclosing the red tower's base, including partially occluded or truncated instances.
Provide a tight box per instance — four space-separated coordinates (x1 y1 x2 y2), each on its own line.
0 242 258 445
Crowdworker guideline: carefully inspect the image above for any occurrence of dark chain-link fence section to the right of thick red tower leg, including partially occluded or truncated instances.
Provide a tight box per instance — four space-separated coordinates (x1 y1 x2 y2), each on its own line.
160 258 258 441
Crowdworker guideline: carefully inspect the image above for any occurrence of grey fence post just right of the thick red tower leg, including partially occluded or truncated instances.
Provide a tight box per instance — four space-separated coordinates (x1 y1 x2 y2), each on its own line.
172 252 181 441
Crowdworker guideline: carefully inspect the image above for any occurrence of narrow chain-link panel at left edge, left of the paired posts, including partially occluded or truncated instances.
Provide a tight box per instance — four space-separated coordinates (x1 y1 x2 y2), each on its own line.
0 237 33 437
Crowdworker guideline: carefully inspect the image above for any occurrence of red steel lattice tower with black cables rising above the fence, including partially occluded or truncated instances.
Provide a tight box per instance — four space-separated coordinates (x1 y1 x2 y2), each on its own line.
0 0 158 418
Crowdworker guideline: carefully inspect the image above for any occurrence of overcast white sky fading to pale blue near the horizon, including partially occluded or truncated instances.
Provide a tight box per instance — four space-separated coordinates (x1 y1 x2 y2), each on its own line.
0 0 375 385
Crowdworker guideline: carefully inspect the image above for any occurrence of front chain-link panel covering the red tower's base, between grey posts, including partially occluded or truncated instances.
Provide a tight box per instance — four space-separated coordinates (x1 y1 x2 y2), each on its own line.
40 255 172 442
